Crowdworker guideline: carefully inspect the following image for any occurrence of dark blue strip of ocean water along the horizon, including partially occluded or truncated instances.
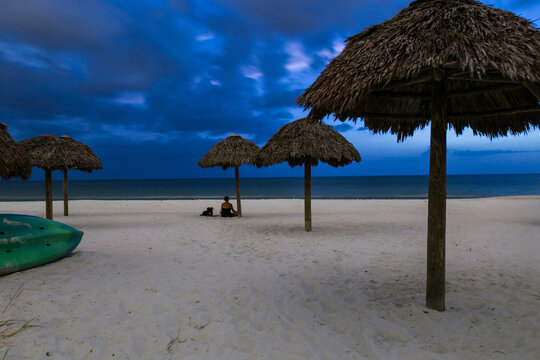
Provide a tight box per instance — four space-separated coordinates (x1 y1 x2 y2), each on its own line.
0 174 540 201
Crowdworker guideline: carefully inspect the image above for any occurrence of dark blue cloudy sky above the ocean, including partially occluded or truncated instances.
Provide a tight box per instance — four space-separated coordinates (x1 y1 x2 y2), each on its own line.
0 0 540 179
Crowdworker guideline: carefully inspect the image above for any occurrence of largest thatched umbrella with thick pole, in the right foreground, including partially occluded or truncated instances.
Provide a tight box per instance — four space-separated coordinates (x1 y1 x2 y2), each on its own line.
297 0 540 311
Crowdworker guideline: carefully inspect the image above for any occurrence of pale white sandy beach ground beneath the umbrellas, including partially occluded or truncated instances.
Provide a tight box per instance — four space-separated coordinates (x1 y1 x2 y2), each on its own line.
0 197 540 360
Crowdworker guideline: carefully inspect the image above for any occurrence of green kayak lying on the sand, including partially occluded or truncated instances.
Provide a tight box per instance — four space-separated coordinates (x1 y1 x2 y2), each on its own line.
0 214 84 275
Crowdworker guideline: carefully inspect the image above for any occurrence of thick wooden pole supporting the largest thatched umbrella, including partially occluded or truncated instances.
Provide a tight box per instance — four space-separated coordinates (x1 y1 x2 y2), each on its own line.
426 70 447 311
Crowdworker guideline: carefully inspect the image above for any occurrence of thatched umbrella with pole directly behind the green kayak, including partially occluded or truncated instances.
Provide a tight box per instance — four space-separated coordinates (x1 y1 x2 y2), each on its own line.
19 134 66 220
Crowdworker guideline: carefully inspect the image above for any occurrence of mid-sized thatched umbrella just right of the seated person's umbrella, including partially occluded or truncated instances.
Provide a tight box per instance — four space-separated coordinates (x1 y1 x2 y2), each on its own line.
257 118 361 231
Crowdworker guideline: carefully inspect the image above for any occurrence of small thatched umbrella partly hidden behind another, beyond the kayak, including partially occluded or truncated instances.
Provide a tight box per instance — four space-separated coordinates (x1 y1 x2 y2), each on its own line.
58 135 103 216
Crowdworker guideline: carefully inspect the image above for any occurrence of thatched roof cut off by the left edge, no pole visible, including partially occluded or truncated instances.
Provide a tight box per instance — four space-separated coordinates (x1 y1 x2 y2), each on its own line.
0 123 32 180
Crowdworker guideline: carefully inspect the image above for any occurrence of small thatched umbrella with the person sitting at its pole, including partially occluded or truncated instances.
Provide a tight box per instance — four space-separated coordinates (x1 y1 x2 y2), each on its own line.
199 134 259 216
